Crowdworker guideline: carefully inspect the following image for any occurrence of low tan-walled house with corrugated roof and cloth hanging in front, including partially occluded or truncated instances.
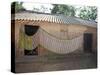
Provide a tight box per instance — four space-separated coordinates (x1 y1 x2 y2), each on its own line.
12 11 97 57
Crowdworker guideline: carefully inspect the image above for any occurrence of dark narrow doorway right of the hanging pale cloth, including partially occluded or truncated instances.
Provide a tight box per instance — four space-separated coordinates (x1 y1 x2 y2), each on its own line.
84 33 93 52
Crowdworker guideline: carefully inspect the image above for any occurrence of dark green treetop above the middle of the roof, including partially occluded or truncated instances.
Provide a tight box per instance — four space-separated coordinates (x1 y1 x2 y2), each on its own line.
51 4 75 16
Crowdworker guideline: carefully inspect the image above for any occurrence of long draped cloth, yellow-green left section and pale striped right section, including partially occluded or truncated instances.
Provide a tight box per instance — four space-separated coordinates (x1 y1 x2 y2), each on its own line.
19 28 83 54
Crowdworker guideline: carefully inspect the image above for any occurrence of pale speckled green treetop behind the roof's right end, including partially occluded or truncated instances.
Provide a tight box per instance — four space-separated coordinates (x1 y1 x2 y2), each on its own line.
79 7 97 20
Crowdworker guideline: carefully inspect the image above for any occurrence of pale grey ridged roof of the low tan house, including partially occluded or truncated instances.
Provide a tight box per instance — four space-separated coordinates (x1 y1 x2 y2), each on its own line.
13 12 97 27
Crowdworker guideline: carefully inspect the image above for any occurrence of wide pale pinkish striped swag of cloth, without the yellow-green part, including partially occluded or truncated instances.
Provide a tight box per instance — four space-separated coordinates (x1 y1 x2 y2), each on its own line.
39 29 83 54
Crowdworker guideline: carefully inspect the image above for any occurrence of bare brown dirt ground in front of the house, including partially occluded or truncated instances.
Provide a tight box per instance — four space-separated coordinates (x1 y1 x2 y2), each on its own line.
16 53 97 73
